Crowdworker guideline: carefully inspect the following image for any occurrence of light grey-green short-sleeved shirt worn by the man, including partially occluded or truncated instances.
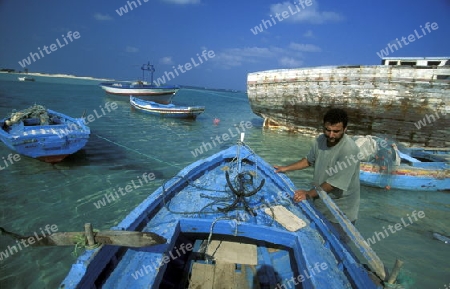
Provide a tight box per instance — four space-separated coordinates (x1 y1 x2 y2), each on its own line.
306 134 360 223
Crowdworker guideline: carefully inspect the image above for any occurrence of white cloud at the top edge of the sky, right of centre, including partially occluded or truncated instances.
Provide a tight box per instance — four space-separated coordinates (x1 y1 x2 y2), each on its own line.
270 0 344 24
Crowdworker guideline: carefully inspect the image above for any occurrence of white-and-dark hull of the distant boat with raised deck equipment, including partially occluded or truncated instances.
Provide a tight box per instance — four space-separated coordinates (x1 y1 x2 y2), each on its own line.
100 83 179 103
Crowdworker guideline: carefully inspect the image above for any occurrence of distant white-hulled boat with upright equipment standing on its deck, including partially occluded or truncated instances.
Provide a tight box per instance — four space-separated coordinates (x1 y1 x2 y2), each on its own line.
99 63 180 104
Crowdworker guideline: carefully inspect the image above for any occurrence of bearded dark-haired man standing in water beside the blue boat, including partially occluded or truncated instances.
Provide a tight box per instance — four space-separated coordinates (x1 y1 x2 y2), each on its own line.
274 108 360 242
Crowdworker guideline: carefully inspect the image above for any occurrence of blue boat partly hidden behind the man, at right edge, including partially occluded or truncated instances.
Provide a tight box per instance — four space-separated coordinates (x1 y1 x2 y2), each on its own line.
354 136 450 191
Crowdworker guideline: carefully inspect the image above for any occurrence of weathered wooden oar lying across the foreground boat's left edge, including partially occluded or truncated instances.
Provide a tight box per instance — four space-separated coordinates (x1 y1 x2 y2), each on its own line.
0 227 166 247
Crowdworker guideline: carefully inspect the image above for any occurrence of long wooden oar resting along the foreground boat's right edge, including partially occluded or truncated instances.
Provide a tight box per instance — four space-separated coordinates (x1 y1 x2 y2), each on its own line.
316 187 386 280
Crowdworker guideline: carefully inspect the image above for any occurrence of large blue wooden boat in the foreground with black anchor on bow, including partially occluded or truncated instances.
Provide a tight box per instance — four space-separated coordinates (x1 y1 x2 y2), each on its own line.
60 139 385 289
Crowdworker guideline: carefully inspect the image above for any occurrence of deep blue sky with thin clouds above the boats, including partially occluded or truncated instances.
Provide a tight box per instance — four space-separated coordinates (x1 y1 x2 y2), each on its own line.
0 0 450 90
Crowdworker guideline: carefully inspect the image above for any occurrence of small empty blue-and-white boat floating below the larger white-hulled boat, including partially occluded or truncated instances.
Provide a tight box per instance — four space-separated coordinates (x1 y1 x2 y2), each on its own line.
130 96 205 119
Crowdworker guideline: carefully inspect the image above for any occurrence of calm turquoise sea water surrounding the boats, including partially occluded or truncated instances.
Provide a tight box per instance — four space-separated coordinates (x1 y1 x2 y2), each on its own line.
0 74 450 289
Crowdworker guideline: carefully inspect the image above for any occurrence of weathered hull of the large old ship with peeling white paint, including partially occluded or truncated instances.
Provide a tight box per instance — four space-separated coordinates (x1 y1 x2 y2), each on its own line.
247 62 450 147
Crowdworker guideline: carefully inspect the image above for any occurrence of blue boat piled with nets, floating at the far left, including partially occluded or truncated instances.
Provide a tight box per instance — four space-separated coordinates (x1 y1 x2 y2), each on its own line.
0 105 90 163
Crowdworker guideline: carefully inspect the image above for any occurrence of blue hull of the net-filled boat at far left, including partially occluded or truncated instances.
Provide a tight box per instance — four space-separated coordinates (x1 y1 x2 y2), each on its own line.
0 109 90 163
